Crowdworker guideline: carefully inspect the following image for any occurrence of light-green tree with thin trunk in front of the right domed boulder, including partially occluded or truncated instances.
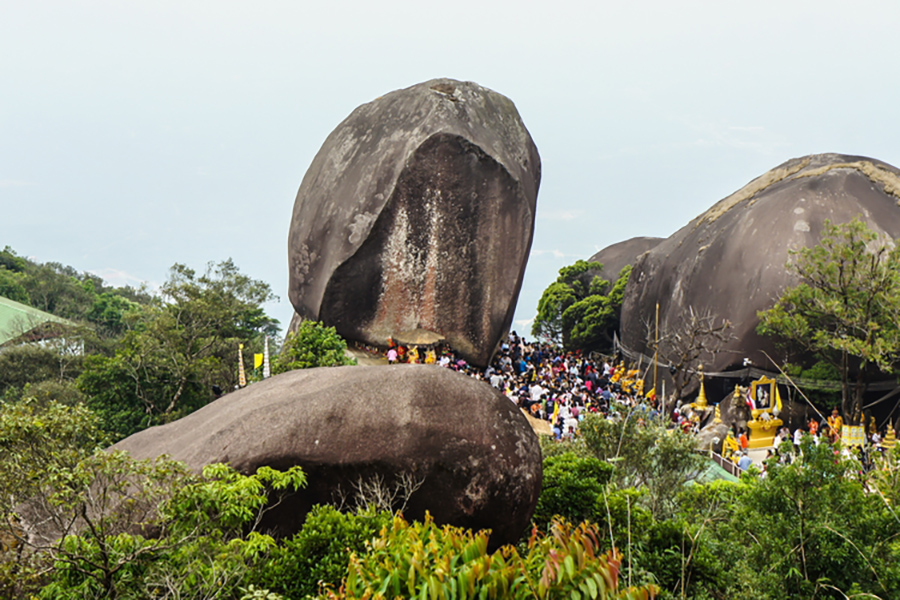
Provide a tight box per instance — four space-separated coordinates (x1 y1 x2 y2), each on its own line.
759 219 900 422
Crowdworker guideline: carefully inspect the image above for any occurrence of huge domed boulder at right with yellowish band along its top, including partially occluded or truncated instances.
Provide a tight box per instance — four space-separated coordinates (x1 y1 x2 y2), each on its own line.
622 154 900 371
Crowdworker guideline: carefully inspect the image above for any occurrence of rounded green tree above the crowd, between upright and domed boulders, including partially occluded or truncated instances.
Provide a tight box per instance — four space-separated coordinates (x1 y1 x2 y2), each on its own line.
531 260 631 350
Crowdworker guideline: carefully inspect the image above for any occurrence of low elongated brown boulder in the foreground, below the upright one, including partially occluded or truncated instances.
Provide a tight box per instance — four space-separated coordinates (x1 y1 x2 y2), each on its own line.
113 365 541 545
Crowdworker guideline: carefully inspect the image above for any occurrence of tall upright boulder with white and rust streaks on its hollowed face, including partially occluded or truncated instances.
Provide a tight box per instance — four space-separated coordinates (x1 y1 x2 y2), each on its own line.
288 79 541 365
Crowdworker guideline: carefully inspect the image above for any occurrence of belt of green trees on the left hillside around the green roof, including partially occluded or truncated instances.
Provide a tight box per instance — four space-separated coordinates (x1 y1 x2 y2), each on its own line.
0 248 288 438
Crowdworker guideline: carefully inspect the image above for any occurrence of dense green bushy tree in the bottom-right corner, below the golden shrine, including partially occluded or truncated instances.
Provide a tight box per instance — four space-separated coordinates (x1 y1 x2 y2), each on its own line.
720 436 900 598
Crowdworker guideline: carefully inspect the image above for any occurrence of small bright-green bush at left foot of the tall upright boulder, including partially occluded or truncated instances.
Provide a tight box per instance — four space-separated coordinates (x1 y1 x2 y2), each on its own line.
273 321 356 374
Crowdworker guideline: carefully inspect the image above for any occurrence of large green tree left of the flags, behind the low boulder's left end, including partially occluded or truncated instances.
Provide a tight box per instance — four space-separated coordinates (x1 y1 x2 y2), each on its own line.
78 260 278 436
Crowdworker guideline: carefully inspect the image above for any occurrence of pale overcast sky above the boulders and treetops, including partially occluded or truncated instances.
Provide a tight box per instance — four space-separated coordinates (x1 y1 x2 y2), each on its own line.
0 0 900 331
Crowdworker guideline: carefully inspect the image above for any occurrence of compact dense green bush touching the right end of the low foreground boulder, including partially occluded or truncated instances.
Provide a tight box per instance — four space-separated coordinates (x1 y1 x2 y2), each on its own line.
532 452 613 529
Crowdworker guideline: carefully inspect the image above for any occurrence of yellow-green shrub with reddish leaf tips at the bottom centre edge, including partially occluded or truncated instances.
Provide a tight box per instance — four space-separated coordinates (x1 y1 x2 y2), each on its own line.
328 515 655 599
